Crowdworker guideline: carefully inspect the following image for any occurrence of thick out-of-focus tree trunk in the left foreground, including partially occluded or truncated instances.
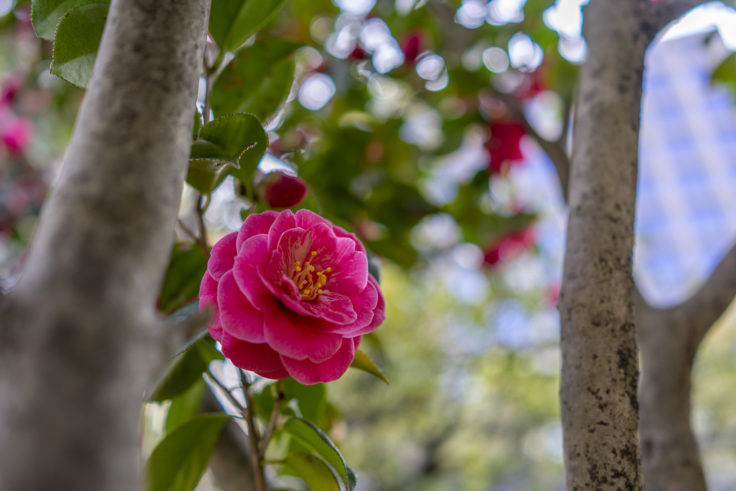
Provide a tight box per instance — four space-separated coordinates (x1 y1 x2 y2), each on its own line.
0 0 209 491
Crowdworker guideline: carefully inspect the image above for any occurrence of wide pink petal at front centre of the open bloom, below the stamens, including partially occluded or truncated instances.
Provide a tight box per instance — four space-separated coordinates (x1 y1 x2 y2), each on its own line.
264 302 342 362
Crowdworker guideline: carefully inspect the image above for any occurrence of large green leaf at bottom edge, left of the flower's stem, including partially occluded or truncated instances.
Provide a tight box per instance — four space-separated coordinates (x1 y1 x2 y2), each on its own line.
145 414 229 491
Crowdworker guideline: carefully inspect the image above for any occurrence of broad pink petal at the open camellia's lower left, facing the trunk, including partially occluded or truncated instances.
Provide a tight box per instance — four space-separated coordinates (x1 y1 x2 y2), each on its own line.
217 271 266 343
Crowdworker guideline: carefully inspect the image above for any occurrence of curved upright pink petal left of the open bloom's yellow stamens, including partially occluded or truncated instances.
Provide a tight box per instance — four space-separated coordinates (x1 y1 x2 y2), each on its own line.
233 235 272 311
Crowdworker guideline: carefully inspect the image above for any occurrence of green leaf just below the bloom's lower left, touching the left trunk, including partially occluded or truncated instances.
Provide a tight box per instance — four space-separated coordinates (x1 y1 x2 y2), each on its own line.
150 336 224 402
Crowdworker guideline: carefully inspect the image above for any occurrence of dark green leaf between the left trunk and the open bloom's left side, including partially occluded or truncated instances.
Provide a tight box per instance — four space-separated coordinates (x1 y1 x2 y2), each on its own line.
159 244 207 313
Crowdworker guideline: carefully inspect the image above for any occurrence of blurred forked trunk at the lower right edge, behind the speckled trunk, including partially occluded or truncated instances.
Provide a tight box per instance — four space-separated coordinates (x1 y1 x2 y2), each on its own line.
635 246 736 491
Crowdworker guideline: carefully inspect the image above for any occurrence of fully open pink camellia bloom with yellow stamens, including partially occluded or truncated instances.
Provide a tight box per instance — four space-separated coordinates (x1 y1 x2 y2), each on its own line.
199 210 385 384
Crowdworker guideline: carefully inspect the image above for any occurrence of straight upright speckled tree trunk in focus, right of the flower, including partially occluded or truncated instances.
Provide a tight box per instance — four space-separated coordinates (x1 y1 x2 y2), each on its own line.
560 0 655 490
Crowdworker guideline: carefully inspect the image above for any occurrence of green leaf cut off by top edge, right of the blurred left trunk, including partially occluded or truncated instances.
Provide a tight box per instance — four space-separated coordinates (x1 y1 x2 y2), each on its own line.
209 0 286 51
